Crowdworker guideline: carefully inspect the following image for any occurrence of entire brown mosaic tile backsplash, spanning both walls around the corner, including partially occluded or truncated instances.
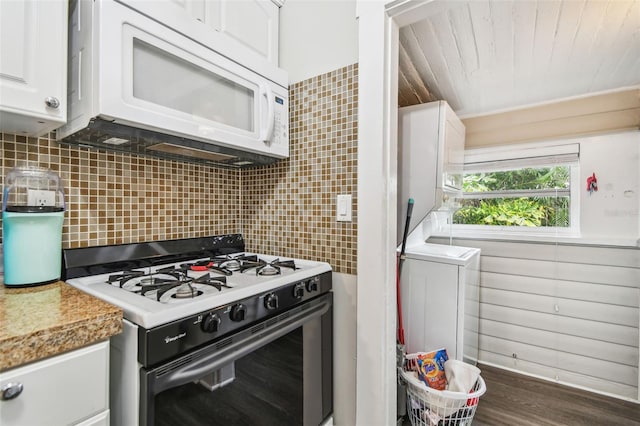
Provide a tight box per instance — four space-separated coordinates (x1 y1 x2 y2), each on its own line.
0 64 358 274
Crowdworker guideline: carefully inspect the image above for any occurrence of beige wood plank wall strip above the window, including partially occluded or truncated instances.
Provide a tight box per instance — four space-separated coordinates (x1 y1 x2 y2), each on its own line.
462 88 640 148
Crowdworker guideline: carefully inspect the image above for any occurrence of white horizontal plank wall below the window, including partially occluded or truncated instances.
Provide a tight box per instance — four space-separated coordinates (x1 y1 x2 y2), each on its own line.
429 239 640 399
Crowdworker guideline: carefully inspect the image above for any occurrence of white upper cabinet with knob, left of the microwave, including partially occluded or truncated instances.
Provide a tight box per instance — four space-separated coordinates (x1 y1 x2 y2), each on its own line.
0 0 67 136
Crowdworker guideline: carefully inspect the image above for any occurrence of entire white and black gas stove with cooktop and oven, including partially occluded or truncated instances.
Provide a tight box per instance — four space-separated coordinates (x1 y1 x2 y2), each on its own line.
63 234 333 426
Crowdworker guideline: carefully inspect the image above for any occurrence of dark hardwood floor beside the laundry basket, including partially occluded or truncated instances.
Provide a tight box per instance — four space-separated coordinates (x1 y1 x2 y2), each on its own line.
473 364 640 426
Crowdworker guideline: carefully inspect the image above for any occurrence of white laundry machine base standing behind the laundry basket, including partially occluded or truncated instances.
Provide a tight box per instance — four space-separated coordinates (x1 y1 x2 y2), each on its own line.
401 243 480 364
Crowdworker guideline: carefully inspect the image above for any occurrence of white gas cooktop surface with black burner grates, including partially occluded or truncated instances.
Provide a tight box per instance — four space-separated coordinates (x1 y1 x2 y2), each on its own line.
66 252 331 329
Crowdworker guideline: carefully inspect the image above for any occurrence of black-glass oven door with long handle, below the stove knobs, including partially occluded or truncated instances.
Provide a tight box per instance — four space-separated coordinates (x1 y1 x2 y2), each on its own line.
140 293 333 426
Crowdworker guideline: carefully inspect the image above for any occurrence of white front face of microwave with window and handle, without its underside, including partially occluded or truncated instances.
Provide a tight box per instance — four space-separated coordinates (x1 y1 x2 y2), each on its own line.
94 1 288 157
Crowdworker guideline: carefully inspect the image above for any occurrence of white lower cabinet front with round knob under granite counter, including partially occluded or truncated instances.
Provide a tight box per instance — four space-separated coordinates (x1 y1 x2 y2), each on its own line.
0 341 109 426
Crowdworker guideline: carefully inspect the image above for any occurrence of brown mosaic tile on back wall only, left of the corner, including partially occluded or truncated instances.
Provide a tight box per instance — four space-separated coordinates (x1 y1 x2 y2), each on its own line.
0 134 240 248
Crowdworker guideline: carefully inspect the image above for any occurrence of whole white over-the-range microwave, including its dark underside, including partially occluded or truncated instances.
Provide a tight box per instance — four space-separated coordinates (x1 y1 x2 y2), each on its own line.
56 0 289 167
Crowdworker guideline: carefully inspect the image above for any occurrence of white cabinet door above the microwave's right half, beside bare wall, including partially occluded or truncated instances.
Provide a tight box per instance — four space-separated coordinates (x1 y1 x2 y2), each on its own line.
206 0 280 66
